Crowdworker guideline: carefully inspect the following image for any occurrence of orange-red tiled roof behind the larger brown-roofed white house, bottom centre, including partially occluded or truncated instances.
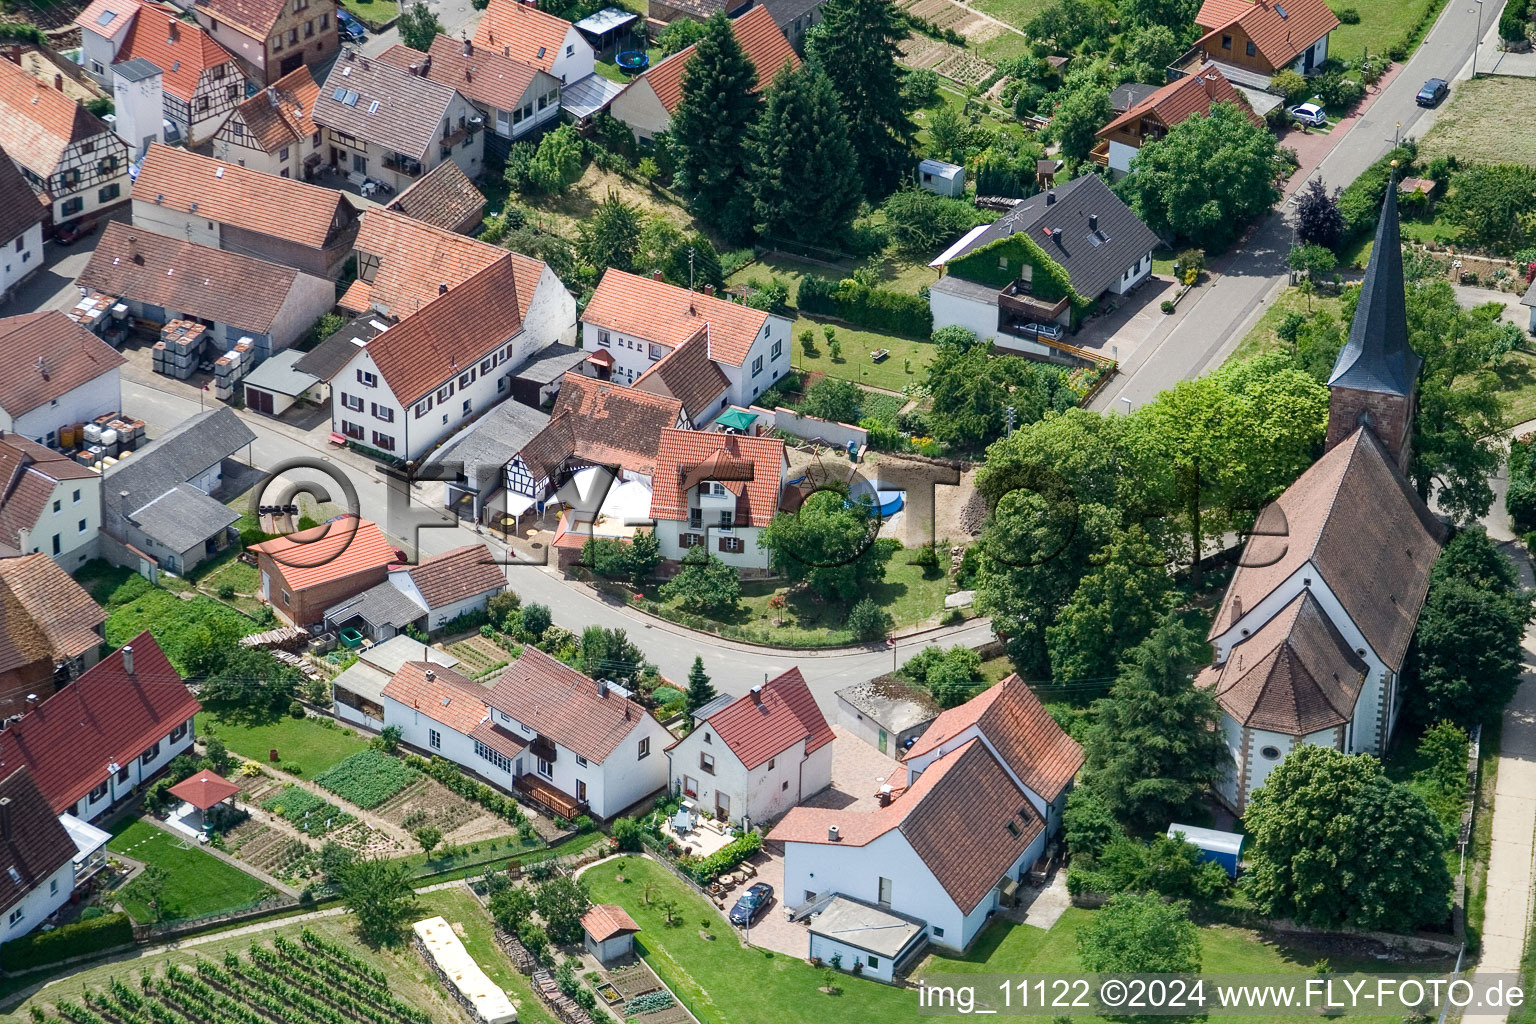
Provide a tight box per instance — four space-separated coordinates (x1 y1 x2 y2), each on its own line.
905 672 1083 800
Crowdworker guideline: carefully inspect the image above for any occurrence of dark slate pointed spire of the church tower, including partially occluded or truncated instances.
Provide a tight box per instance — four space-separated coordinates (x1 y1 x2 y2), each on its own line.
1329 181 1421 395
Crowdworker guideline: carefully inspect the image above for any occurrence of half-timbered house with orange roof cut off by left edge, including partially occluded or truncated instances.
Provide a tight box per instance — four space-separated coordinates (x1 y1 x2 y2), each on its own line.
0 60 129 224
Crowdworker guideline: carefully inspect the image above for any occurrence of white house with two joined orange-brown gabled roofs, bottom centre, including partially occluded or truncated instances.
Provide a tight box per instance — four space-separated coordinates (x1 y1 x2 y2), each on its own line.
768 674 1083 951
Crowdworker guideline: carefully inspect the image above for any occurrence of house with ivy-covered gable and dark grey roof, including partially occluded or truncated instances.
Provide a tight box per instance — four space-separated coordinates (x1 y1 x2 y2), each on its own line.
928 175 1161 359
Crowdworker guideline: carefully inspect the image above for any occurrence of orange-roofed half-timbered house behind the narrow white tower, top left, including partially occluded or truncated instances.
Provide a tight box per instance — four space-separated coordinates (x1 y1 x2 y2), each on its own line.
75 0 246 146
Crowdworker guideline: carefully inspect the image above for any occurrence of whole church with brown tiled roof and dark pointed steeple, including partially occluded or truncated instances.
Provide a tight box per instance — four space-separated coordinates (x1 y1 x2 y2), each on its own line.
1195 184 1445 815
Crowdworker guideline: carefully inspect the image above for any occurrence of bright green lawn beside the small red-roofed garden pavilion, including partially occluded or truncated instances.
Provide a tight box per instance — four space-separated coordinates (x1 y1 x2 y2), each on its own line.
108 818 272 924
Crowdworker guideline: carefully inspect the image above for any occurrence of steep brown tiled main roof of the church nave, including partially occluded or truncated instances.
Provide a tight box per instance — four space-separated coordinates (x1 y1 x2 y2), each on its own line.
1210 427 1445 671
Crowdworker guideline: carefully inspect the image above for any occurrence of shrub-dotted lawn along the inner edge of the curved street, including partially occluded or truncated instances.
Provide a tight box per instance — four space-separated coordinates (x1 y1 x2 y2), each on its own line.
642 550 948 646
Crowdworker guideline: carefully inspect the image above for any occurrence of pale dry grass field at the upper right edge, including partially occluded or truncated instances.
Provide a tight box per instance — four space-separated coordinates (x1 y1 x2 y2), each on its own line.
1419 76 1536 164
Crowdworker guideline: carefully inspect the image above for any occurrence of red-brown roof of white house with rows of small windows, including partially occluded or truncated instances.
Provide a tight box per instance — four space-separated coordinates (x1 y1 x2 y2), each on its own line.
367 253 522 408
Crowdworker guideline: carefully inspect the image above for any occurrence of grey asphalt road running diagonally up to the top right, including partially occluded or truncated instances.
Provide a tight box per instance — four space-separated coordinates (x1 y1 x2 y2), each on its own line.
1092 0 1502 411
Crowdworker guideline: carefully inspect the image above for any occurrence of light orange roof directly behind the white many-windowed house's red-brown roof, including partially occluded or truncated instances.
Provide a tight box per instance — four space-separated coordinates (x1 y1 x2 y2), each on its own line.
347 209 544 319
